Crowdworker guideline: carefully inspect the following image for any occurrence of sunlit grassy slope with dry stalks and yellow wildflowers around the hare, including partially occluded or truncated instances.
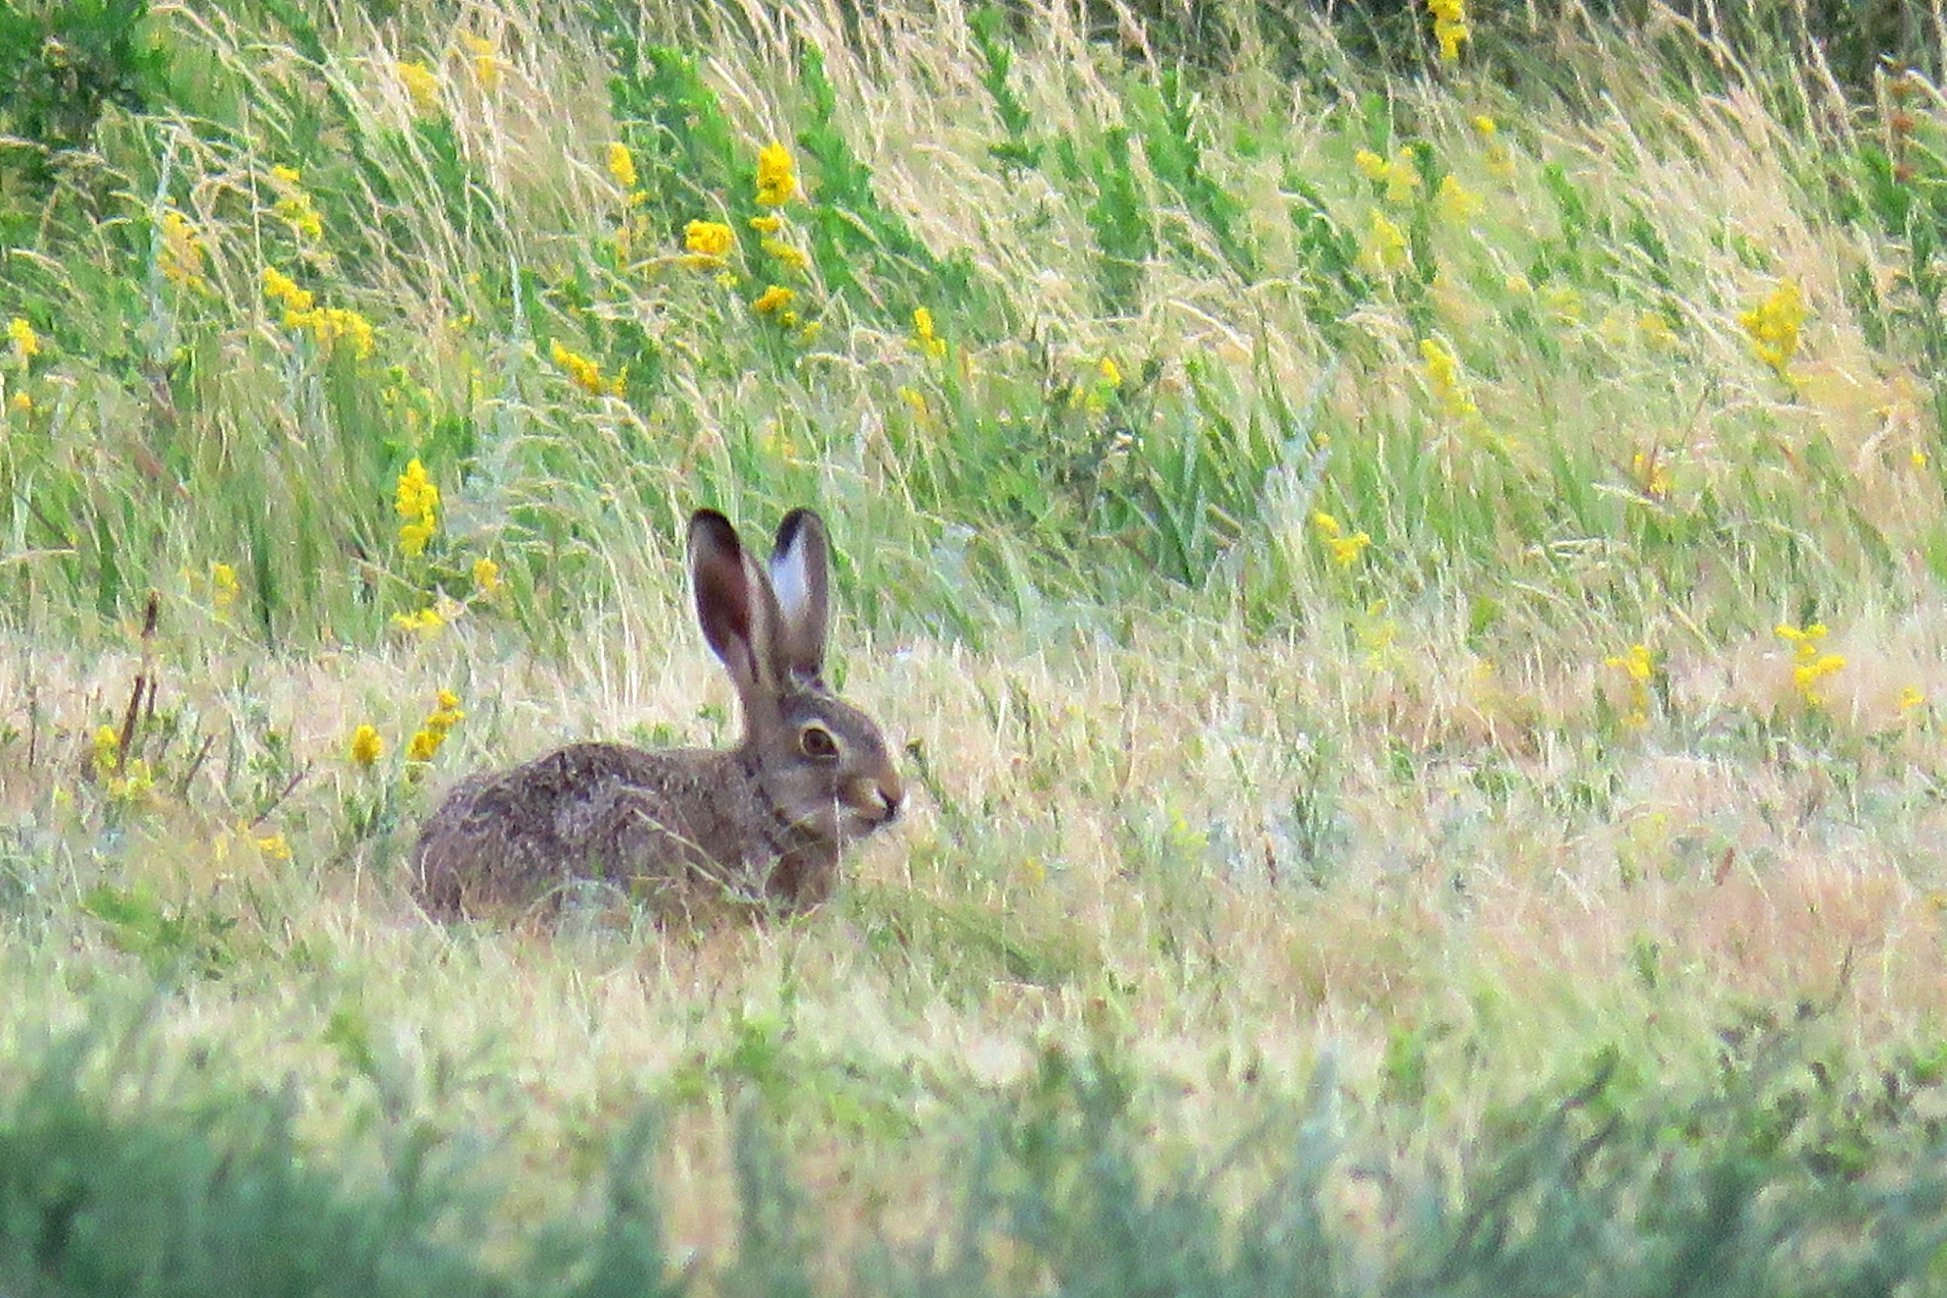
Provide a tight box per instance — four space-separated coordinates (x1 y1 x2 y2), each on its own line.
0 6 1947 1265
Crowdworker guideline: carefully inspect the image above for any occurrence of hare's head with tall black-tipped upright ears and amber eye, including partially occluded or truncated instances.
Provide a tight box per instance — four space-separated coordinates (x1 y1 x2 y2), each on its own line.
689 510 905 843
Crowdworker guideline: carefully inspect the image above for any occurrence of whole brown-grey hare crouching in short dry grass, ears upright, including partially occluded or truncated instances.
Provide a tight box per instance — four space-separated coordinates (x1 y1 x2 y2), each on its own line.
413 510 905 917
